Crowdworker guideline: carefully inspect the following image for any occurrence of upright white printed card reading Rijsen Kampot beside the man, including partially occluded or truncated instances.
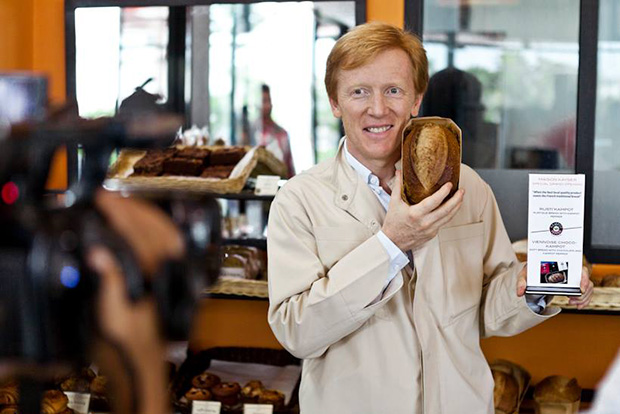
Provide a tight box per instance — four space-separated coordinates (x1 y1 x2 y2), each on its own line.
526 174 585 295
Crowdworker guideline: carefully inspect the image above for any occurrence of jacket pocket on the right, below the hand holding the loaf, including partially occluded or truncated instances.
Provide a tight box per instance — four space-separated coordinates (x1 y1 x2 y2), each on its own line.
439 222 484 325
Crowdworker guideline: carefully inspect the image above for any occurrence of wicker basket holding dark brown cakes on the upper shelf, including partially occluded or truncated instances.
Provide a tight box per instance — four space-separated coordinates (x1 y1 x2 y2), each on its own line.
104 146 260 194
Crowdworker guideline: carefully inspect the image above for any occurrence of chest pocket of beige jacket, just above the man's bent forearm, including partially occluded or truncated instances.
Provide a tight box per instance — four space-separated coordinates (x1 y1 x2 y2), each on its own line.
314 225 372 269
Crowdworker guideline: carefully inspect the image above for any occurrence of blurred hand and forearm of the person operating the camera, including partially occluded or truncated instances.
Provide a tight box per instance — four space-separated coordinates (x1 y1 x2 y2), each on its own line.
87 191 185 414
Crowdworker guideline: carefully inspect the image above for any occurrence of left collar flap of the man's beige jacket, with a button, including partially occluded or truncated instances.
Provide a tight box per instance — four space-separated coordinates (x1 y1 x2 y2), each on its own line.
332 137 385 234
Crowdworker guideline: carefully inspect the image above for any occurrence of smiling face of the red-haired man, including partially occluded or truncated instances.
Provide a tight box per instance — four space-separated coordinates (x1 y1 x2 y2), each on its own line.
330 49 422 168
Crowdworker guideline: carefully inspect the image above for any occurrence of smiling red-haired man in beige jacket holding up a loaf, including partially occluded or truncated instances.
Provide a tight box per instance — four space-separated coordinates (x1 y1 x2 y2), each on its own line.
268 23 591 414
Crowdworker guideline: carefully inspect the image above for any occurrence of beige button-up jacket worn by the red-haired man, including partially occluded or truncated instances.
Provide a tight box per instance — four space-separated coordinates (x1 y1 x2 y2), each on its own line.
268 145 559 414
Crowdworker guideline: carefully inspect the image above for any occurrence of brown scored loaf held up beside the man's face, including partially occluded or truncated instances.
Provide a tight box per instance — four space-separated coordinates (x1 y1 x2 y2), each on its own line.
402 117 461 205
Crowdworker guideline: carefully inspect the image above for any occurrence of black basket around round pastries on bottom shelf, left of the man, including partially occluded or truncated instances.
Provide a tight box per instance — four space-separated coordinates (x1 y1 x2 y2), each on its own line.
171 347 301 414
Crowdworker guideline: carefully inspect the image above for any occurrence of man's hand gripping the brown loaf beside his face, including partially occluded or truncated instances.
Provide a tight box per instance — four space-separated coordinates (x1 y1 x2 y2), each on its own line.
381 171 465 251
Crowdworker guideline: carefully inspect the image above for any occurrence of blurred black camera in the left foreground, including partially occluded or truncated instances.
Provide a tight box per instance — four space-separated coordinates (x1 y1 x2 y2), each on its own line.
0 114 221 377
